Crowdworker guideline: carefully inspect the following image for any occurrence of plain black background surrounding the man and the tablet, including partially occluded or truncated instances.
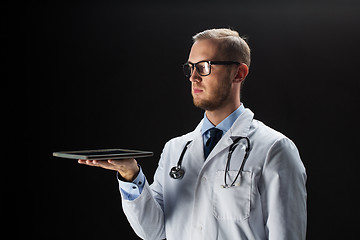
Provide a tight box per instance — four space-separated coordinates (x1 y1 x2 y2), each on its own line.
1 1 360 239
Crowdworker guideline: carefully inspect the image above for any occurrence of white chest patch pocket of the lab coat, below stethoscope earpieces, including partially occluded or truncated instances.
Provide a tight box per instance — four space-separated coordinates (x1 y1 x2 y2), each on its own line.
213 171 252 221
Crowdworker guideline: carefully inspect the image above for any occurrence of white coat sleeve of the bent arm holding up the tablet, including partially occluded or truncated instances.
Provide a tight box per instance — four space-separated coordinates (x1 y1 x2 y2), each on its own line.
120 143 166 240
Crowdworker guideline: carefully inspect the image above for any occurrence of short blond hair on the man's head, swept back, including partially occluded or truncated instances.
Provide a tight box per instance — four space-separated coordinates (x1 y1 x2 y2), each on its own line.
193 28 250 67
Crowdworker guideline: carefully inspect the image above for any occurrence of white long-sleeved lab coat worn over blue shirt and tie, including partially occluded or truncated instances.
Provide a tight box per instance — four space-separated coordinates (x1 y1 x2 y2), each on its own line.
120 109 307 240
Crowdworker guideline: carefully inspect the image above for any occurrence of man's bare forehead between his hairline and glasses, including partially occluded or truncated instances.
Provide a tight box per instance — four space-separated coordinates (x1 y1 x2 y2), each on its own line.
188 39 223 63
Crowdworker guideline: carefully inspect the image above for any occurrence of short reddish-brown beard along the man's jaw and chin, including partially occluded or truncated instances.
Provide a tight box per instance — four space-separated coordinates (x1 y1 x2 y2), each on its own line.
193 81 231 111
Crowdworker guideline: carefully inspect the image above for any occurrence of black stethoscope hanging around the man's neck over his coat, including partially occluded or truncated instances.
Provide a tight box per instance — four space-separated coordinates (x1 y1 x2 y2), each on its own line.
169 137 250 188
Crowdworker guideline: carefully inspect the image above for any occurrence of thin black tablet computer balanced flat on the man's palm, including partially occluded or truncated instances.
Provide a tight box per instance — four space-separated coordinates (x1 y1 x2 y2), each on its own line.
53 149 154 160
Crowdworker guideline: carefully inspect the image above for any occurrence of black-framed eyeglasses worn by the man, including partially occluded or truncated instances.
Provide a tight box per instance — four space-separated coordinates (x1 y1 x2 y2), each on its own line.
183 61 240 78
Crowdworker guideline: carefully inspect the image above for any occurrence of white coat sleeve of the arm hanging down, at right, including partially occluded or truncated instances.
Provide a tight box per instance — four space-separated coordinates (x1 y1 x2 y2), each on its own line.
259 138 307 240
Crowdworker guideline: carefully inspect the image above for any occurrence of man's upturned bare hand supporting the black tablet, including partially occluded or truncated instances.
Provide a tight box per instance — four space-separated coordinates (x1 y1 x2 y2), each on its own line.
78 158 140 182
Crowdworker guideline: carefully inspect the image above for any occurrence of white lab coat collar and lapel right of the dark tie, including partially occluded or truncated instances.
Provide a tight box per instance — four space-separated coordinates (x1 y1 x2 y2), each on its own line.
206 108 254 162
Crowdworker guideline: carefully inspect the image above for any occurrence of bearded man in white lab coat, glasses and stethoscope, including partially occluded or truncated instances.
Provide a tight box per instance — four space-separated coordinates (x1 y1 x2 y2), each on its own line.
79 29 307 240
